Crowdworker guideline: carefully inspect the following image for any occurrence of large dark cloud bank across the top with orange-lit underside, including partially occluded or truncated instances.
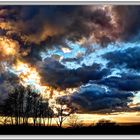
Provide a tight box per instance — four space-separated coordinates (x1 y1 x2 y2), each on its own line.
0 5 116 63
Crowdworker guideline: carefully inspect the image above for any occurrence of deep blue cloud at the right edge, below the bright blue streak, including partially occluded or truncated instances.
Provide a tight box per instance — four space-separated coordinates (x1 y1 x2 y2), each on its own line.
103 46 140 70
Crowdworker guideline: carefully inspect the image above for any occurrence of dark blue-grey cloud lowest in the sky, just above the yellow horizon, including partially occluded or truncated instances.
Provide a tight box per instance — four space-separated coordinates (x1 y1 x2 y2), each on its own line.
60 84 133 113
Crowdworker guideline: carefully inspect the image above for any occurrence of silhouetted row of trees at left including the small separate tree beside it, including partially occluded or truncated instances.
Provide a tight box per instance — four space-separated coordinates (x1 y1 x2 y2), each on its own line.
0 85 75 127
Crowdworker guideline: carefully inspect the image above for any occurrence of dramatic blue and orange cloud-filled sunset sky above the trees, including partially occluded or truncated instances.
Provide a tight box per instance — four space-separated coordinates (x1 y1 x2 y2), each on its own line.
0 4 140 122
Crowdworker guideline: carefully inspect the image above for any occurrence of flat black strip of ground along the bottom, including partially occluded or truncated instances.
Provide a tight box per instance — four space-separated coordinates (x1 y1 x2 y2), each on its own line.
0 125 140 135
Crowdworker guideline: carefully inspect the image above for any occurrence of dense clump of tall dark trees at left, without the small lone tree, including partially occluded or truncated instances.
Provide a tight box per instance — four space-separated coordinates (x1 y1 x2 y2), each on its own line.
2 85 53 126
